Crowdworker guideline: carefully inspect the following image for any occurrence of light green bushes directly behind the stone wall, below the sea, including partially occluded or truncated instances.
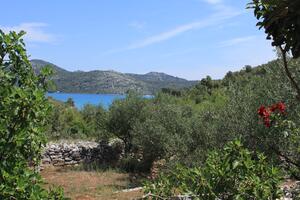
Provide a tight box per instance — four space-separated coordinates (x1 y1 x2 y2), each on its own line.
46 98 111 140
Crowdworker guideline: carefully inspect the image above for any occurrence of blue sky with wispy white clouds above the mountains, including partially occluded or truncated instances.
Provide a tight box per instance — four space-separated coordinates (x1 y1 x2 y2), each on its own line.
0 0 276 80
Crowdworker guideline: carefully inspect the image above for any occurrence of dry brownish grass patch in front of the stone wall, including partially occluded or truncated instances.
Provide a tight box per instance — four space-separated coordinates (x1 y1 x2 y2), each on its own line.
41 167 143 200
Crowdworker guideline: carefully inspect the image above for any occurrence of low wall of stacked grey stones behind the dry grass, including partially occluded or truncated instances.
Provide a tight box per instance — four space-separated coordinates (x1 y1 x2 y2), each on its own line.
42 140 124 166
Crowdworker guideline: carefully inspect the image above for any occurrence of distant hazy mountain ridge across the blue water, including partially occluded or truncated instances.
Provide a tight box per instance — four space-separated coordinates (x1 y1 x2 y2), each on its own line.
31 60 197 94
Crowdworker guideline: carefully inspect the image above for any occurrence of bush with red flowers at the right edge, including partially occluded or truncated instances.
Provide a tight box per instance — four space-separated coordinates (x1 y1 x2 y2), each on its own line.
258 102 300 178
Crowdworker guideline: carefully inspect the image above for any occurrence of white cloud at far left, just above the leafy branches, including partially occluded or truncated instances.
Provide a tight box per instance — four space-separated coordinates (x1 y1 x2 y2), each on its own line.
0 22 57 43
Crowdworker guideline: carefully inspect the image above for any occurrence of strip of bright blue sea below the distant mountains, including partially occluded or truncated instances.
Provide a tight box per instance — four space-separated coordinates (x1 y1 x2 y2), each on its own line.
47 93 125 109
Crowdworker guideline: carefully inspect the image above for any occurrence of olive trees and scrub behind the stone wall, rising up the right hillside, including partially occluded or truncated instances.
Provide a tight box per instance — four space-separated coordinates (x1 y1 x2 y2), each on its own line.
42 56 300 183
